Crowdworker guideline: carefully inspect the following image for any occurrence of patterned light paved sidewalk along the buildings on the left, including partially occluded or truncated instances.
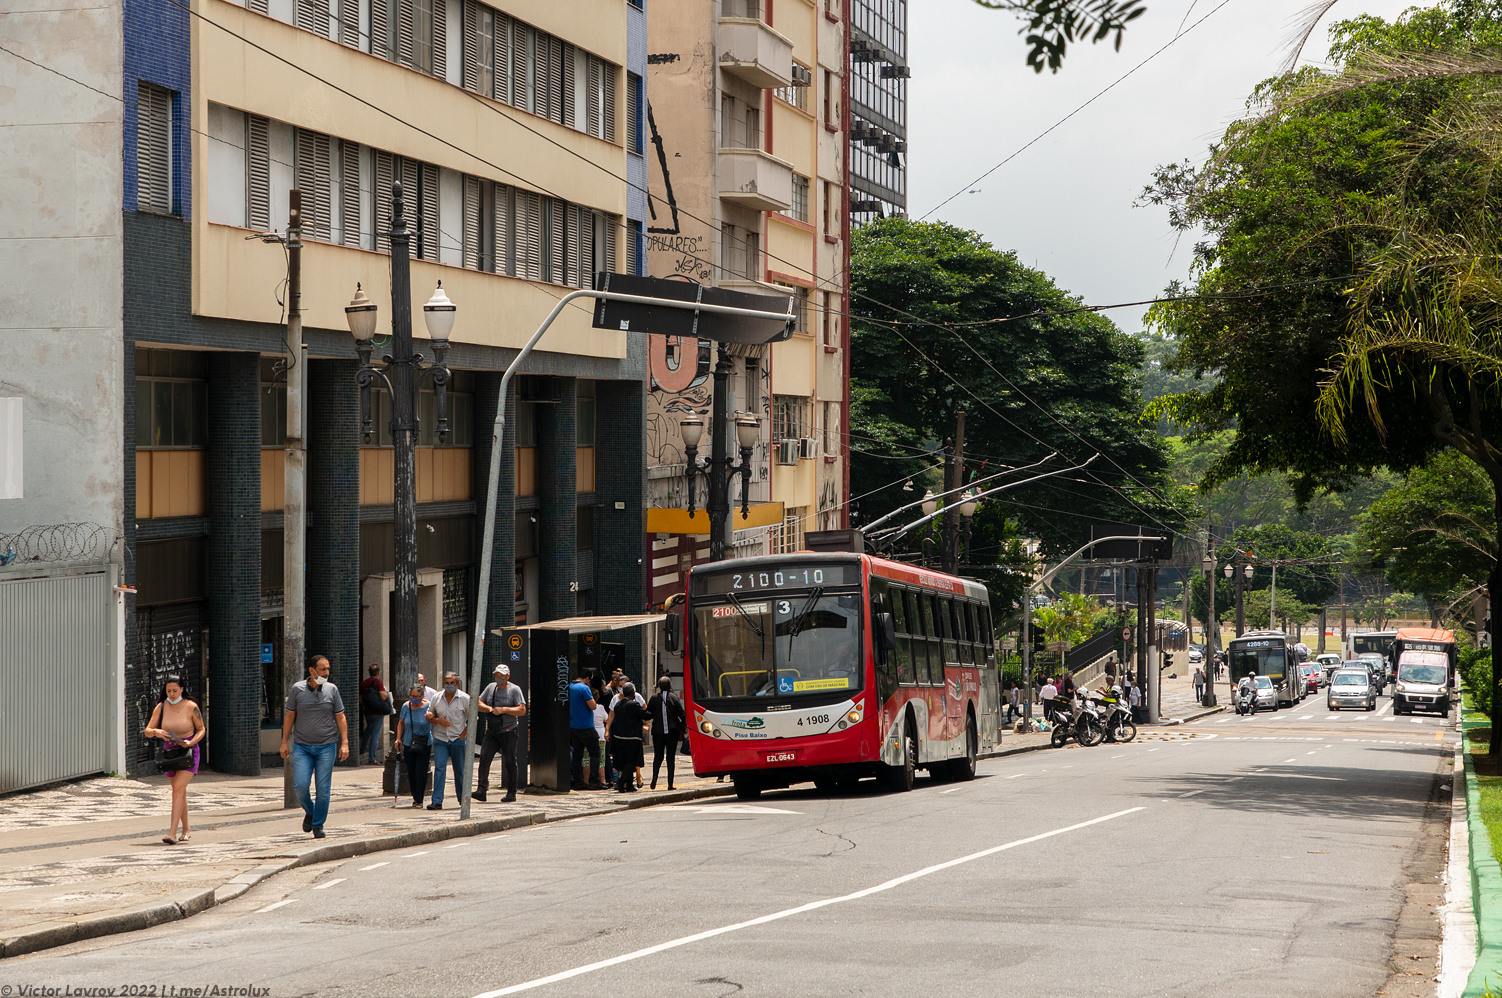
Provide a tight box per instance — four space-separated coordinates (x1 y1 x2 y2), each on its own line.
0 682 1211 957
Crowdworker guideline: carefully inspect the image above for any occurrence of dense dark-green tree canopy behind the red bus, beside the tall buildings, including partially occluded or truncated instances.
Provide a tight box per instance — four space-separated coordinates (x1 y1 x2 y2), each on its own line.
850 218 1182 595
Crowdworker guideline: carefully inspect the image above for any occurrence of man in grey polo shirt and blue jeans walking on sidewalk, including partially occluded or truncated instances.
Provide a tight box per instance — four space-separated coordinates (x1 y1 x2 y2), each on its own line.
281 655 350 839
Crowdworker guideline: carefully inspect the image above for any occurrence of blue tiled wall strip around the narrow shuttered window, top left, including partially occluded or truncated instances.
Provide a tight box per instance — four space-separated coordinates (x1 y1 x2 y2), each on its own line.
122 0 192 218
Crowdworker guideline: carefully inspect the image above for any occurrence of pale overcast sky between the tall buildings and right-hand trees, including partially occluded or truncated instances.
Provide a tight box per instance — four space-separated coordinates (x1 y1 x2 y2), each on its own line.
907 0 1413 332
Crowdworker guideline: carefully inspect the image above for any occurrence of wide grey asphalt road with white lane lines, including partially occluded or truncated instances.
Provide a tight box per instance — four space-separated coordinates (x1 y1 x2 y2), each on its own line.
0 697 1454 998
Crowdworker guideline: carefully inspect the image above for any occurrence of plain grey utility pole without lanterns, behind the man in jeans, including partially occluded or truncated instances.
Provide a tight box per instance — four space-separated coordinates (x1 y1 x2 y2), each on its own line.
282 189 308 807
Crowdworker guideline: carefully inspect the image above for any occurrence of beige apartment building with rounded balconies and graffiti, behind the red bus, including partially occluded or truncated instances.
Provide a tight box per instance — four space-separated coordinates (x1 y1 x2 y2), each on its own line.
644 0 849 603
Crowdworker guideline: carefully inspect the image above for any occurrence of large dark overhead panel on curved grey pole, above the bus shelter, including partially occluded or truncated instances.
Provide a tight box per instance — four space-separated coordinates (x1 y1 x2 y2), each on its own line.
592 274 798 346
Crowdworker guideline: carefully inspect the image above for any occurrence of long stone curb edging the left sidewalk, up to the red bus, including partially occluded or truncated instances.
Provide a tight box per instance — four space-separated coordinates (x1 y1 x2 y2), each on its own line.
0 783 734 959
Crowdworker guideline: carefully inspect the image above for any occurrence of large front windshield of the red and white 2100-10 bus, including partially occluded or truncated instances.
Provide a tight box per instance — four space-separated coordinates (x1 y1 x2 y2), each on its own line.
689 588 862 700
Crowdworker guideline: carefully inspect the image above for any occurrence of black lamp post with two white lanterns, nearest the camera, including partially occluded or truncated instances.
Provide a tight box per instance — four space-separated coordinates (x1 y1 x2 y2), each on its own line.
344 183 463 712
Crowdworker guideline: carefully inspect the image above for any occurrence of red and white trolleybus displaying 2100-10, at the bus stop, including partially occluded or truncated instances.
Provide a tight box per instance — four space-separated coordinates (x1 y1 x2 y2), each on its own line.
683 552 1000 798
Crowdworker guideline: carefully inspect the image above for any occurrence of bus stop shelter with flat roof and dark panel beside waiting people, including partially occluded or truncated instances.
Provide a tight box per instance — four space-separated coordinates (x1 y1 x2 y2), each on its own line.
491 613 667 794
